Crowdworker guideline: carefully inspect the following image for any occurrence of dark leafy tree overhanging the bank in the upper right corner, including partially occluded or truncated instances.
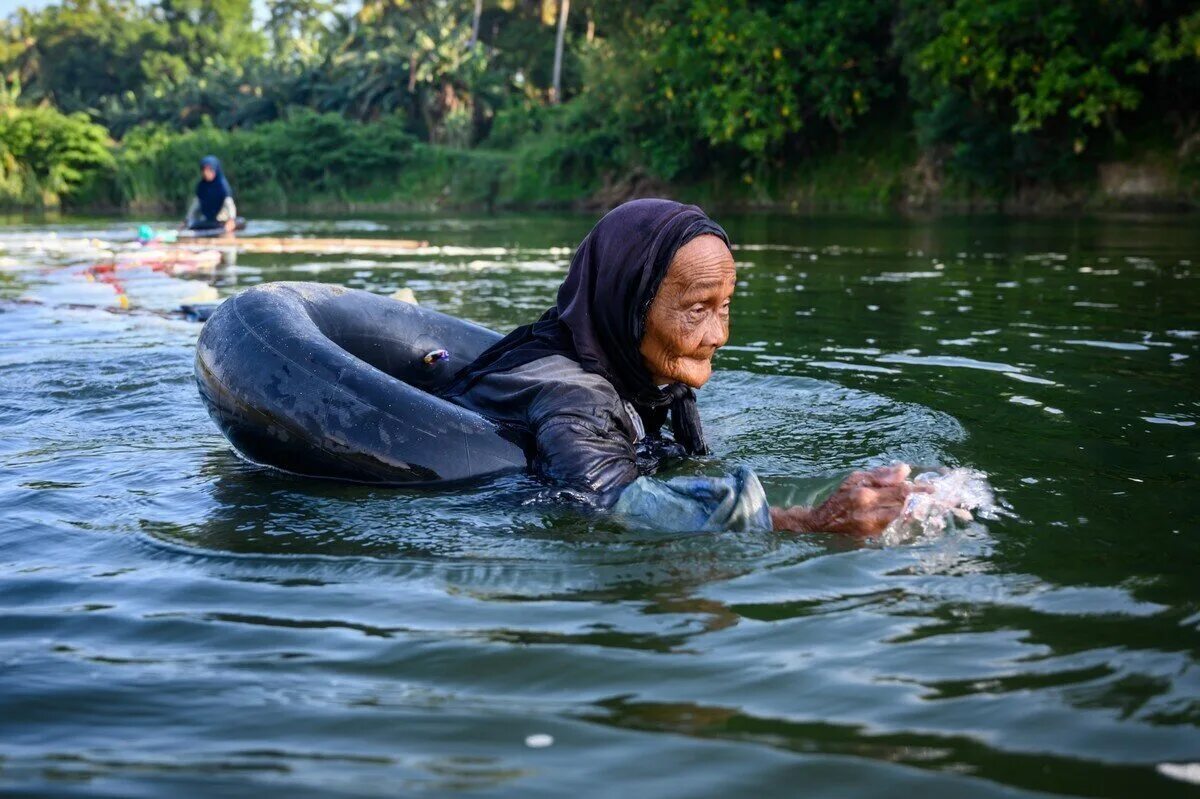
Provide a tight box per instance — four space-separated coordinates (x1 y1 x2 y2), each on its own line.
896 0 1189 193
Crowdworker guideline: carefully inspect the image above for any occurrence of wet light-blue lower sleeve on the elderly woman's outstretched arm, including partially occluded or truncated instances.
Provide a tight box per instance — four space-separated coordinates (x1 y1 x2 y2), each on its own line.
612 467 772 533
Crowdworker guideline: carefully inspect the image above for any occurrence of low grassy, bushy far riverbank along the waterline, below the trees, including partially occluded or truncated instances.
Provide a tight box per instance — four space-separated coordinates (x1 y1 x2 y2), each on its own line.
21 105 1200 216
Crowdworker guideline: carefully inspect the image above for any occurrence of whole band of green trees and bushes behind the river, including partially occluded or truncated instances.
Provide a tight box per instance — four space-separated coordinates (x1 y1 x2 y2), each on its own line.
0 0 1200 210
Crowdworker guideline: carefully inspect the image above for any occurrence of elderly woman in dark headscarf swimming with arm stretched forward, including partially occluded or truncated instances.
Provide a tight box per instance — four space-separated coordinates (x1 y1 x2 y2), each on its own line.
445 199 919 535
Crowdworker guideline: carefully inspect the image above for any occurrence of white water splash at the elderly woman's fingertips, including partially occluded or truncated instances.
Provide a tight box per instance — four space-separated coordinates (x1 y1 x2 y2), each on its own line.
881 469 998 546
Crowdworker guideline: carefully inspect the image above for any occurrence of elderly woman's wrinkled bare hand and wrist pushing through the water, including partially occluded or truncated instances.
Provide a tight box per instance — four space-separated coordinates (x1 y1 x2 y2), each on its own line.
770 463 932 535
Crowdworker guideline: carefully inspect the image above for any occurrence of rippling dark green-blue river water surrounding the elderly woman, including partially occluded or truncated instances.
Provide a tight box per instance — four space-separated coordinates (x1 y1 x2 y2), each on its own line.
0 215 1200 798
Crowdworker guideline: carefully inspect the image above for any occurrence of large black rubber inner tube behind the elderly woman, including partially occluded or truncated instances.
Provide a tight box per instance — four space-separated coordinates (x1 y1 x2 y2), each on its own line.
196 283 529 485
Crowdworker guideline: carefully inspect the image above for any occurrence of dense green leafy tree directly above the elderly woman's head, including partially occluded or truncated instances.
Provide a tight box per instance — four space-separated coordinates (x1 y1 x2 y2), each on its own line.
589 0 893 178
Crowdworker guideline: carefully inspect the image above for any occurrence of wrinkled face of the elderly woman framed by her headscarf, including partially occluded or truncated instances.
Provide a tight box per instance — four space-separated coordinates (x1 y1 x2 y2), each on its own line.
641 235 737 389
